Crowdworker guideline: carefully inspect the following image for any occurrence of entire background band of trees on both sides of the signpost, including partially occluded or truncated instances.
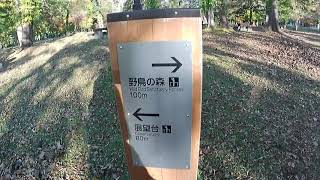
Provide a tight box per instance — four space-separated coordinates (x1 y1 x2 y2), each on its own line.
0 0 320 48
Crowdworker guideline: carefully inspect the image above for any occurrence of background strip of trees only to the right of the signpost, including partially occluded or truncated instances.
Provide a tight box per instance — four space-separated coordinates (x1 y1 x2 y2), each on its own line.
200 0 320 31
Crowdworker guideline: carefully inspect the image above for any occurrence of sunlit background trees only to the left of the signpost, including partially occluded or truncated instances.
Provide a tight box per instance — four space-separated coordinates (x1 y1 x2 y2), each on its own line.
0 0 112 48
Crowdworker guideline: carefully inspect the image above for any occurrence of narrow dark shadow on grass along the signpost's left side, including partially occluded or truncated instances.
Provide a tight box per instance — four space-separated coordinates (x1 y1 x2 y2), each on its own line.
86 66 127 179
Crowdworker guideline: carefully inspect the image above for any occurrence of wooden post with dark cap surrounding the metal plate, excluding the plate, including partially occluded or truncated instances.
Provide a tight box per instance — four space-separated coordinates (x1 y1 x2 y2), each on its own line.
107 9 202 180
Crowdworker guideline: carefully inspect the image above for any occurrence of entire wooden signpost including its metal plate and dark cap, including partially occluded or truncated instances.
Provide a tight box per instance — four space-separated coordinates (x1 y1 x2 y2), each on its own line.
107 9 202 180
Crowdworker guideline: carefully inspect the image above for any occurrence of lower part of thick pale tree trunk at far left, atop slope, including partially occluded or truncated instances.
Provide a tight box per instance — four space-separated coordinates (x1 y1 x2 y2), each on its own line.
17 23 32 49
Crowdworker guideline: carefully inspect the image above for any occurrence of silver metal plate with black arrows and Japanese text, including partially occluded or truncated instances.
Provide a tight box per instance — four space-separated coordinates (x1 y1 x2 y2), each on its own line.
117 41 192 169
